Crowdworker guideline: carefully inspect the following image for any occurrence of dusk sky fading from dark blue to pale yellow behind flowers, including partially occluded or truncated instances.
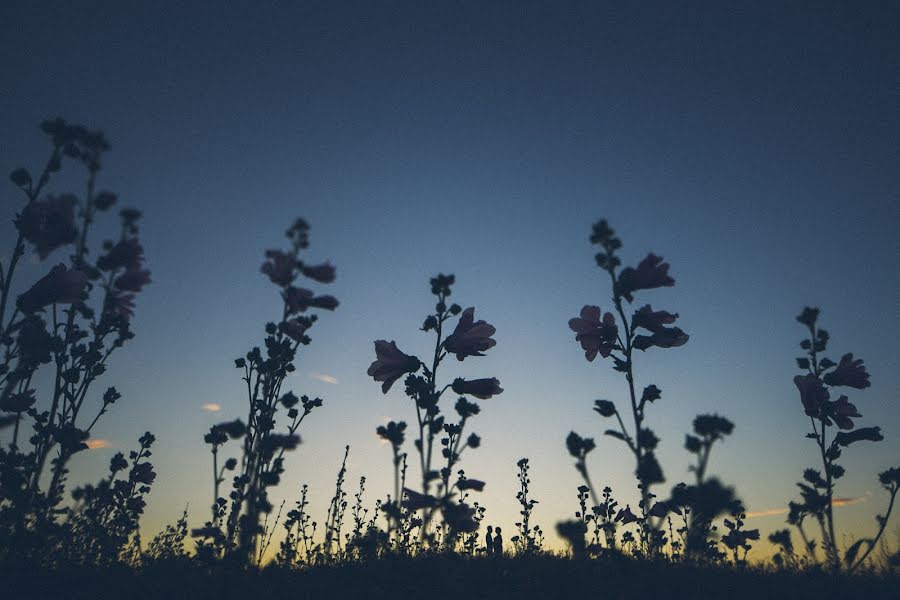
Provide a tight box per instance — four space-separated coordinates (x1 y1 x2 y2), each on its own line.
0 1 900 556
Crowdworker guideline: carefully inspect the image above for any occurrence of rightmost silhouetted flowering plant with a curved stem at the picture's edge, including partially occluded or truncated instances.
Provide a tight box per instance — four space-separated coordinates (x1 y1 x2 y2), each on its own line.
788 307 900 571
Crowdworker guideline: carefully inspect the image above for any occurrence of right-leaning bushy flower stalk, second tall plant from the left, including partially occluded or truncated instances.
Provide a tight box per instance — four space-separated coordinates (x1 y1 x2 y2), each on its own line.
192 219 338 563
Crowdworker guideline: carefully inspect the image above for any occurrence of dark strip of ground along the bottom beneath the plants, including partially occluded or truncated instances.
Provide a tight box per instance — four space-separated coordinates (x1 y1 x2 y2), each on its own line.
0 556 900 600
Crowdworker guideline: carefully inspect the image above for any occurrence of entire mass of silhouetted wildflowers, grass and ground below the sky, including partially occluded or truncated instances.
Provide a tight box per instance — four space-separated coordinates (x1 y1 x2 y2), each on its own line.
0 119 900 600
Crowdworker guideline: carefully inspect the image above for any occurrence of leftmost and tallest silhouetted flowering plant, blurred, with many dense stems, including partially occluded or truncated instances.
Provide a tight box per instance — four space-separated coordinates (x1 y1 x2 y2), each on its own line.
0 118 150 559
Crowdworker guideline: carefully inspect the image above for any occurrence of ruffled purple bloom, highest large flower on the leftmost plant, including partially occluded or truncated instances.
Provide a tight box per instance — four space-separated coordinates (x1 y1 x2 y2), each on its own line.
16 194 78 259
